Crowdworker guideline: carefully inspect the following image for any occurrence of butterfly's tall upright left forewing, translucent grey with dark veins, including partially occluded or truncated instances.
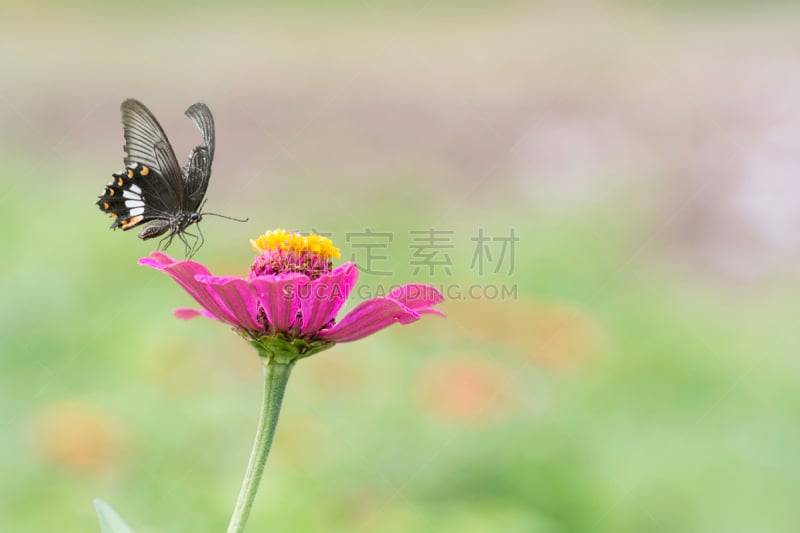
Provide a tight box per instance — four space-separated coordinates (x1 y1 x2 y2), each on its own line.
120 98 186 210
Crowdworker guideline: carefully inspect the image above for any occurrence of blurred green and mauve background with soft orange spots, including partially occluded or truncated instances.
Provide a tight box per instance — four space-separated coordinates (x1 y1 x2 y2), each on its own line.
0 0 800 533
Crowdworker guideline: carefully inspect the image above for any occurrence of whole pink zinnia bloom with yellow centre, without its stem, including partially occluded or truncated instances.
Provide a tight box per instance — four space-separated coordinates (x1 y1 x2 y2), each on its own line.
139 230 444 360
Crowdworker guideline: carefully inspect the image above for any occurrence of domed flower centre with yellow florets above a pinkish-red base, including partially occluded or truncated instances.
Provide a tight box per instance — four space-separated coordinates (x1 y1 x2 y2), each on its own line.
250 229 339 279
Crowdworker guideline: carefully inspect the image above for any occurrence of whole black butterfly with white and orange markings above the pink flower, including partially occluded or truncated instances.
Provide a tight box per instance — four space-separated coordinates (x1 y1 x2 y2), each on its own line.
97 99 222 257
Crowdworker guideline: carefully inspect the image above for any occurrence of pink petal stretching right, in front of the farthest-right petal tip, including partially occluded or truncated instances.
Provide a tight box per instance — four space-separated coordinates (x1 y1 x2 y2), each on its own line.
317 298 419 342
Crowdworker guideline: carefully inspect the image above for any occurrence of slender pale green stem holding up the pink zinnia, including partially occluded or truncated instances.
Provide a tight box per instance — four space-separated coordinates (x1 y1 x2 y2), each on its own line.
228 358 294 533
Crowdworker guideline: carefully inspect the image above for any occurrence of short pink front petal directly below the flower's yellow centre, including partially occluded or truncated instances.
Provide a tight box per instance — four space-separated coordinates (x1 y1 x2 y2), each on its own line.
250 273 309 332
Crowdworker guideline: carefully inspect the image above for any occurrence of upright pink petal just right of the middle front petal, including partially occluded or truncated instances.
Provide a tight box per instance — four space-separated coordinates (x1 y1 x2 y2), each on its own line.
300 263 358 336
